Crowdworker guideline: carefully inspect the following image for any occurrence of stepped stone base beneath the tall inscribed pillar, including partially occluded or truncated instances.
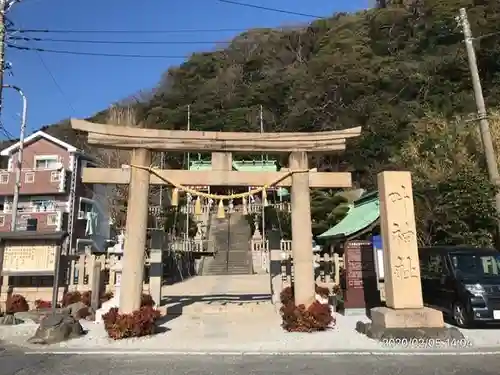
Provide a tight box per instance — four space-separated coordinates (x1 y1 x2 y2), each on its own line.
356 307 465 349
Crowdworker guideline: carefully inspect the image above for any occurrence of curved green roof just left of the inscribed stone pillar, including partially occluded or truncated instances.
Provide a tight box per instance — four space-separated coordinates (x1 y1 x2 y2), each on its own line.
318 192 380 242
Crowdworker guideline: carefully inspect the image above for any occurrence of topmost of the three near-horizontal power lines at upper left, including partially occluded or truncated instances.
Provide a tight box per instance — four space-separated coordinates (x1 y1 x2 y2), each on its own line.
8 28 248 34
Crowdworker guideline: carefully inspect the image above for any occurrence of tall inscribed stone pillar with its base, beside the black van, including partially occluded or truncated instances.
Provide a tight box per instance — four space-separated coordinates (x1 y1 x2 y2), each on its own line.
358 171 461 339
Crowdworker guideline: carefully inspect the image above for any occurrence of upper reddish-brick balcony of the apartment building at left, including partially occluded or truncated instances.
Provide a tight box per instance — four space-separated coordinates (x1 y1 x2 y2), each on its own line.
0 169 69 196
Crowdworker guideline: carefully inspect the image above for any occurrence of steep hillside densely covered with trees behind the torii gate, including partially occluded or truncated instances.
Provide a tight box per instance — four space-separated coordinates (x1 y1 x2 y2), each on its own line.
24 0 500 245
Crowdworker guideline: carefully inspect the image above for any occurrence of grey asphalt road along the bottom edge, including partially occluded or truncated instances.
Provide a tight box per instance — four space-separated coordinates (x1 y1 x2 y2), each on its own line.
0 351 500 375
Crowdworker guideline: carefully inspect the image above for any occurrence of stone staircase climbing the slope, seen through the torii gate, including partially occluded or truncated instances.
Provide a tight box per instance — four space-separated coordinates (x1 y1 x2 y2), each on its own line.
202 212 253 275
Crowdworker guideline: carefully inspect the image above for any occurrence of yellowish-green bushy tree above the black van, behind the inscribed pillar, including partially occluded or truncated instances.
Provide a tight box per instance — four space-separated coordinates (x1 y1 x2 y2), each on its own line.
393 116 497 246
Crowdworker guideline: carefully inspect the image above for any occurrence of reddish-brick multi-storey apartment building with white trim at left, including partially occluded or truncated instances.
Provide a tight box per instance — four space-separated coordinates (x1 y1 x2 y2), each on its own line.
0 131 110 253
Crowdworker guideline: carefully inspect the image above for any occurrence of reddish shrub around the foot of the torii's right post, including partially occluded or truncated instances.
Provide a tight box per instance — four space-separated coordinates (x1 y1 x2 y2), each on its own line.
280 286 335 332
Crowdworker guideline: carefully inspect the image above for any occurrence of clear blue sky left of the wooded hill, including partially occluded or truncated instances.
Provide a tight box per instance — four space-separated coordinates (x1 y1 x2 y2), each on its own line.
0 0 370 138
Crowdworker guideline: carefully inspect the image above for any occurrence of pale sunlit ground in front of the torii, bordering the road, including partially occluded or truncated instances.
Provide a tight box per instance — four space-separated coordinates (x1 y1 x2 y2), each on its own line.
0 313 500 352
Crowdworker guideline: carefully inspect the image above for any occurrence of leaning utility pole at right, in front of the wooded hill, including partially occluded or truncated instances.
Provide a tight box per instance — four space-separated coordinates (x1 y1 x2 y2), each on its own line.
459 8 500 229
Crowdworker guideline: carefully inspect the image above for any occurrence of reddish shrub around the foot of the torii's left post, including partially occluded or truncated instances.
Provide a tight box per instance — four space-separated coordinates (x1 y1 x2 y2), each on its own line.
102 306 161 340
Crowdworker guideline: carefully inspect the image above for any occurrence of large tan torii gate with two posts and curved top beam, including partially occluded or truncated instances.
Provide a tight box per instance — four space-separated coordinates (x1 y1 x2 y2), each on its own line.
71 119 361 313
